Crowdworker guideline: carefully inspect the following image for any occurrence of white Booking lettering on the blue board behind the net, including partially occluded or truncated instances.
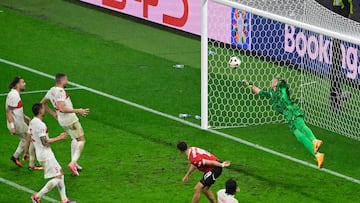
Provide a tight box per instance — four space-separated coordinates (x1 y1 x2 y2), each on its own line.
284 24 360 79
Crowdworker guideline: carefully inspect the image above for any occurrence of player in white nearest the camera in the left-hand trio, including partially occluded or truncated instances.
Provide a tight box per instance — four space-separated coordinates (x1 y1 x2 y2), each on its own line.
24 103 74 203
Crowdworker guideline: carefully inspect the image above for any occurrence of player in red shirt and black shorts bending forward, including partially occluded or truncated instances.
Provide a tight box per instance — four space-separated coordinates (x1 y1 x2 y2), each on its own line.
177 142 230 203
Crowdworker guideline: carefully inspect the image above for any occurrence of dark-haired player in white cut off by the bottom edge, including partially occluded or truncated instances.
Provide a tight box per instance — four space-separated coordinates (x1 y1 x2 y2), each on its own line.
217 179 240 203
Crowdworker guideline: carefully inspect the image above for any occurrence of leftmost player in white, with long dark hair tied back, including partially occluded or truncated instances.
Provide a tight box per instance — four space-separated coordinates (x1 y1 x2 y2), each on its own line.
6 76 42 170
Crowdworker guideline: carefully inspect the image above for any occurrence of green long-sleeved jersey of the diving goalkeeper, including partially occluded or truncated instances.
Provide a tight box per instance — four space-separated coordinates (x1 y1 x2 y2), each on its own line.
259 80 304 121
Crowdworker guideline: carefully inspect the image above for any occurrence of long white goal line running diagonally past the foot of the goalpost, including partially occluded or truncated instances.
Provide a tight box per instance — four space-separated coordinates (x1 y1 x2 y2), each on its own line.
0 58 360 184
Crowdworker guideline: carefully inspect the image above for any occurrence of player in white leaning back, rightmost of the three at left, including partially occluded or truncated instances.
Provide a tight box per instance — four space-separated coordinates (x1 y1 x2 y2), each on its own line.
41 73 89 176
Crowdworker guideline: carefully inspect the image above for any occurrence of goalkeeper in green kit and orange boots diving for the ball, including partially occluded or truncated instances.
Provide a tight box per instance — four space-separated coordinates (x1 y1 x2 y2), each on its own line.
242 76 325 168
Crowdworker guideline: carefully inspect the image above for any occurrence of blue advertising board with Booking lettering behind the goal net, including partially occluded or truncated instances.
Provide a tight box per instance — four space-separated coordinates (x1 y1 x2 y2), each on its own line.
231 9 360 80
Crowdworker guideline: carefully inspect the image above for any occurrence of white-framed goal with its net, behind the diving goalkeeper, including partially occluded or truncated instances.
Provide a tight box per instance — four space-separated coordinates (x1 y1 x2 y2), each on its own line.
202 0 360 140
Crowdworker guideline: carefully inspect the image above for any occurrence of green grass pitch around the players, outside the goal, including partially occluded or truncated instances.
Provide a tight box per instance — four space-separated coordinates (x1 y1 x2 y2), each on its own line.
0 0 360 203
